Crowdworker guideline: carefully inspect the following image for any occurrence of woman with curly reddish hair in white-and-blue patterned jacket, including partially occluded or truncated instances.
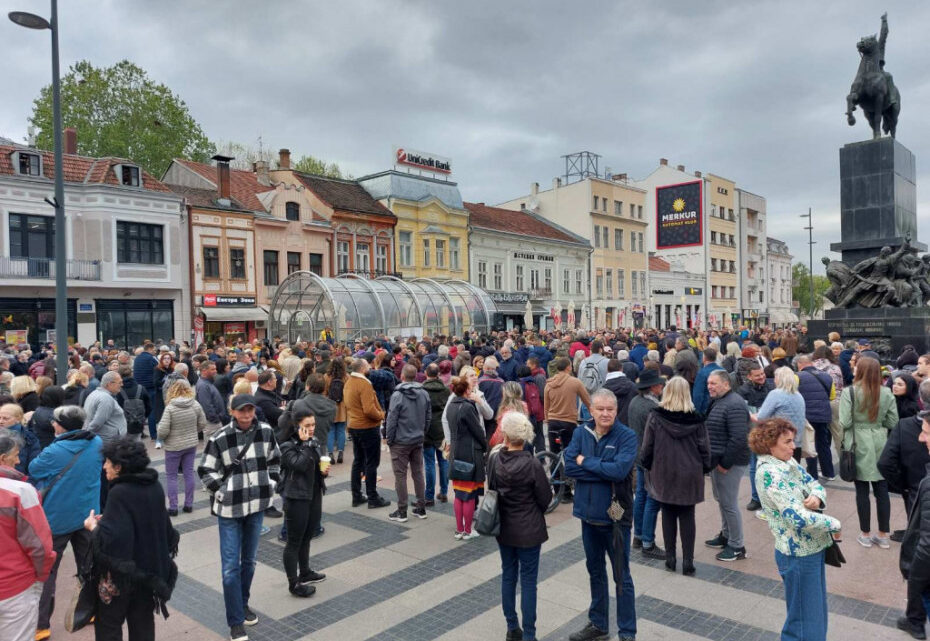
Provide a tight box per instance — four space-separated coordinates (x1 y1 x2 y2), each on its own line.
749 418 841 641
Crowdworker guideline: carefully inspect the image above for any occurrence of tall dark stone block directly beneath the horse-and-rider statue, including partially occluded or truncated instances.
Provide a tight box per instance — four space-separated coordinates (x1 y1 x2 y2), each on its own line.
830 137 927 267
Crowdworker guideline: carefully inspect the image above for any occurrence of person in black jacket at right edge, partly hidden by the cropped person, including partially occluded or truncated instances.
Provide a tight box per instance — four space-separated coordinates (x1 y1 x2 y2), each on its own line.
878 381 930 639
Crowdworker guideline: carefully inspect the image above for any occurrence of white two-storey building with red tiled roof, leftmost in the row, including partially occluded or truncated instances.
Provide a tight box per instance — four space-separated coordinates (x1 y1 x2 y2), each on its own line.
0 130 191 346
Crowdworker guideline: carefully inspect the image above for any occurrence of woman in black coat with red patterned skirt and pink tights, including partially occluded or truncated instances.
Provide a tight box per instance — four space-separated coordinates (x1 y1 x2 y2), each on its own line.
446 377 488 541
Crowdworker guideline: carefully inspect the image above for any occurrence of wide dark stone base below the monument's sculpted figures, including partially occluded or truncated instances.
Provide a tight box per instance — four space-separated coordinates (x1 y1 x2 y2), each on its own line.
807 306 930 360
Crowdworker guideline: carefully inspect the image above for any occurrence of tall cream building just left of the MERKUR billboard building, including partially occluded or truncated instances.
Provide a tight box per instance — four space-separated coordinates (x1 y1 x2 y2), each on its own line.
500 175 649 327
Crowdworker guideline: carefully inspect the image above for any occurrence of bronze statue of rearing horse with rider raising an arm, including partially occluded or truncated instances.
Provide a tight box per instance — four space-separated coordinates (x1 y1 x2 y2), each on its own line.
846 14 901 138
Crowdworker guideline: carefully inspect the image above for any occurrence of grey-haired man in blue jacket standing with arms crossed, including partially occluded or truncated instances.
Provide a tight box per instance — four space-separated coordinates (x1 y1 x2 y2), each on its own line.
565 389 638 641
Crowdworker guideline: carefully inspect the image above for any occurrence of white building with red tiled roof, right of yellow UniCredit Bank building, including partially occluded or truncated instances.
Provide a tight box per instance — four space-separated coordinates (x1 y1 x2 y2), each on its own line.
465 203 591 330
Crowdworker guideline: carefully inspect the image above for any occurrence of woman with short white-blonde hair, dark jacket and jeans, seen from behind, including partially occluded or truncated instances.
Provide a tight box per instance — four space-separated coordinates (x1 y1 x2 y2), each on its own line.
488 412 552 640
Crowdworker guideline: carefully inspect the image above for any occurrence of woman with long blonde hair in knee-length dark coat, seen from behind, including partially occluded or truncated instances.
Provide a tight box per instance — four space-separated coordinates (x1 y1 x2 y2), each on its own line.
640 376 711 575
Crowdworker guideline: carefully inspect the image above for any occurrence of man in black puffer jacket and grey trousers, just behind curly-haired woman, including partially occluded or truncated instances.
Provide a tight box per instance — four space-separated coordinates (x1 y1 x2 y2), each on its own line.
704 369 749 561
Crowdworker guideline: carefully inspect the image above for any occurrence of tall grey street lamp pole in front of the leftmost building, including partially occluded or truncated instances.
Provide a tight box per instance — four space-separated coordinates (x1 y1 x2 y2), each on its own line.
9 0 68 385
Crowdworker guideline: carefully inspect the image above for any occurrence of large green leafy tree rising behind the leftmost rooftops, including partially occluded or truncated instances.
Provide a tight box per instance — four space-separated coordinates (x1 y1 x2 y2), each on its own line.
29 60 214 177
